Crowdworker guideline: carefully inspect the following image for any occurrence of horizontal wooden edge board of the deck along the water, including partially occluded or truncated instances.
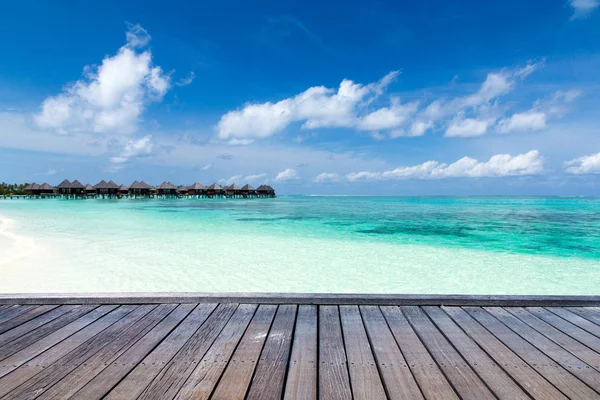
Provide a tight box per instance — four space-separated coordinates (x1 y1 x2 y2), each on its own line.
0 292 600 307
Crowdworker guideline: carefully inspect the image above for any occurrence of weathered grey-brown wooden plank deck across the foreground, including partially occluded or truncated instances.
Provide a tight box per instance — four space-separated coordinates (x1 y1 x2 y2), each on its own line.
0 296 600 400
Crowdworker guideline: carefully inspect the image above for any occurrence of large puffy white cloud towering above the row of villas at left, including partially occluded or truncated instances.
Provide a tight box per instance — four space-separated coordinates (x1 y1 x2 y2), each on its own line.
35 25 170 134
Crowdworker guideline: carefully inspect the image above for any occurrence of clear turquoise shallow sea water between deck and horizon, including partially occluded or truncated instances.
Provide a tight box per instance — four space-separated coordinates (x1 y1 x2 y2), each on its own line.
0 197 600 294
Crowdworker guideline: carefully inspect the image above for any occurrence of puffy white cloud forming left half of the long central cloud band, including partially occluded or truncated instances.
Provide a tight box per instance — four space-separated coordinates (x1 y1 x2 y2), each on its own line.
217 71 398 140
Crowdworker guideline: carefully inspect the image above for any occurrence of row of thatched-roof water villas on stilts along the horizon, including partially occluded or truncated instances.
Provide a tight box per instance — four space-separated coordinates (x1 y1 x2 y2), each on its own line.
25 179 275 199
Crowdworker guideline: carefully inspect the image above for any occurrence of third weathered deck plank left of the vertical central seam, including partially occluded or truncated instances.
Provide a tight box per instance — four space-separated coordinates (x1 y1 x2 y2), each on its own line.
211 304 277 400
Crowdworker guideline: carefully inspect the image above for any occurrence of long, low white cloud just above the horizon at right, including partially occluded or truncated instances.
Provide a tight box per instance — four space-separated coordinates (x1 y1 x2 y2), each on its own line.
346 150 544 182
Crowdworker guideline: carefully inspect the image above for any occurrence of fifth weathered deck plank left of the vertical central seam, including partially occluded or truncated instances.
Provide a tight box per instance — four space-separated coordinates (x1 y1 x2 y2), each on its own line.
139 304 238 400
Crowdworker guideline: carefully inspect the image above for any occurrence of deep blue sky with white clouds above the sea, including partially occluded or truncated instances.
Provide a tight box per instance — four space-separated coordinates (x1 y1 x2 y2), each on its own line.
0 0 600 195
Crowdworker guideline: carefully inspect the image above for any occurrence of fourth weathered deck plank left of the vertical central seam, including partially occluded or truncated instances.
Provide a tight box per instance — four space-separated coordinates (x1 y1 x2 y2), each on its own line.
175 304 257 400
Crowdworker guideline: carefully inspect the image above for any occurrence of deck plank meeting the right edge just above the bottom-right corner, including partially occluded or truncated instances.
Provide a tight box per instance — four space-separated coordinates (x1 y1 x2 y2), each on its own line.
485 307 600 393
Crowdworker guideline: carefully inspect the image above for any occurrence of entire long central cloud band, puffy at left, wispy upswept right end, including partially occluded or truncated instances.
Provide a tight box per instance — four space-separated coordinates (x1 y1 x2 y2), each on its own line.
216 61 543 144
